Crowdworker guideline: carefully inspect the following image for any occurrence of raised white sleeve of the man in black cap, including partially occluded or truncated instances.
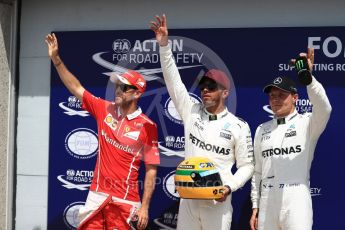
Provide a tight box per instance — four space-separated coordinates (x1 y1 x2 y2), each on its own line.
307 76 332 139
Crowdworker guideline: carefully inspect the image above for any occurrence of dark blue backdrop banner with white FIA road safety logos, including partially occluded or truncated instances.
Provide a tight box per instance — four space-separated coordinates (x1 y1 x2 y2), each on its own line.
48 27 345 230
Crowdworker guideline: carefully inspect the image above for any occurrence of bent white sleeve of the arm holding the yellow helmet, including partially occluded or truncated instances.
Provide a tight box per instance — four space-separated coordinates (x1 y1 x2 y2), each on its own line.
224 123 254 192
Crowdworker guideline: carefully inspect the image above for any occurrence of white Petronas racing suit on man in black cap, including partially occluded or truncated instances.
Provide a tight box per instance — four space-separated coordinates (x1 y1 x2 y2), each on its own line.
251 77 332 230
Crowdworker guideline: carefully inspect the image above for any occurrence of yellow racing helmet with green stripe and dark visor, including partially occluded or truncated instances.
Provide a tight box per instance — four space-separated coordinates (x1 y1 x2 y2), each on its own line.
175 157 224 199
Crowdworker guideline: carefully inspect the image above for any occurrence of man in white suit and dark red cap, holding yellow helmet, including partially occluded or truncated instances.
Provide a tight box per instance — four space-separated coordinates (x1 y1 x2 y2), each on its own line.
151 15 254 230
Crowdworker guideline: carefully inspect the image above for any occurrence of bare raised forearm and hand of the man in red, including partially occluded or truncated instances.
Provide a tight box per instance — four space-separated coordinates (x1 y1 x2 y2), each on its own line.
45 33 85 102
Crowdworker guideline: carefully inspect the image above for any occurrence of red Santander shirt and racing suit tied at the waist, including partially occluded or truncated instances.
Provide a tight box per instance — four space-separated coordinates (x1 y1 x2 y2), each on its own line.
79 91 160 229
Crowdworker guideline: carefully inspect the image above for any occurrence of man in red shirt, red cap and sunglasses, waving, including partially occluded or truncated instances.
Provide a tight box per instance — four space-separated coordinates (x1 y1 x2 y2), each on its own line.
46 34 160 229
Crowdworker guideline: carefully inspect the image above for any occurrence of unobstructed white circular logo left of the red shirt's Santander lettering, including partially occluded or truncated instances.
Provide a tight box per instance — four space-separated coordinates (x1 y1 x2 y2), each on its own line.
65 128 98 159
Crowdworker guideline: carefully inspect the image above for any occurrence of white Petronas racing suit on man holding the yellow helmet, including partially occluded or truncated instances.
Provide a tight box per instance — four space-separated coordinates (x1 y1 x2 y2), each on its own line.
160 46 254 230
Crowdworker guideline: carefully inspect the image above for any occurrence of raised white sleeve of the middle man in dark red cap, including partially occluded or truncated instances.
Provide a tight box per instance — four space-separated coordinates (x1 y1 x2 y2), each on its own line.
159 45 193 122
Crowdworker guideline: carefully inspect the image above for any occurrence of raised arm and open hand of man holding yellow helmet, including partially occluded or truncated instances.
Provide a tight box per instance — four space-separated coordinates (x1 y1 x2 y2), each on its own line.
151 14 193 121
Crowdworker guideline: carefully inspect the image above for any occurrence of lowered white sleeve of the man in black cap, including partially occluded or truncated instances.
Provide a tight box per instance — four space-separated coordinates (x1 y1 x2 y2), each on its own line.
250 125 262 208
